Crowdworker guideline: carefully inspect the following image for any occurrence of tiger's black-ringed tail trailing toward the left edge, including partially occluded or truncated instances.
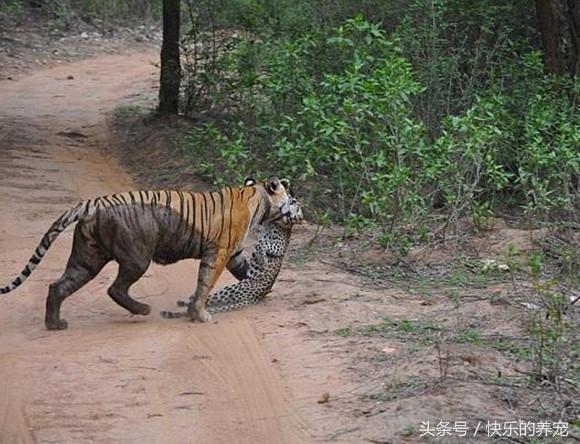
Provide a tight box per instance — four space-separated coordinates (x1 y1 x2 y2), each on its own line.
0 201 90 294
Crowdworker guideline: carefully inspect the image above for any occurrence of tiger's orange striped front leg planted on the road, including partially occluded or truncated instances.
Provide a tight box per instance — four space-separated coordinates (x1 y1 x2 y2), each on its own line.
187 250 230 322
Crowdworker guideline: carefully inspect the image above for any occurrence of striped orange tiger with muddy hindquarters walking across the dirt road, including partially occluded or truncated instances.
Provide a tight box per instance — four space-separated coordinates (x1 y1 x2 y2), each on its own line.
0 176 295 330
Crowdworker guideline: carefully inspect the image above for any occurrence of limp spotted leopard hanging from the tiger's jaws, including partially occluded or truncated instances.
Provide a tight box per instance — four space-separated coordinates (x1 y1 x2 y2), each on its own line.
161 193 303 318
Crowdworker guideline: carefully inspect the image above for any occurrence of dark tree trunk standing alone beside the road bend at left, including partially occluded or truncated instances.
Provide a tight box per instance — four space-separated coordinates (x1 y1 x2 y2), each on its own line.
159 0 181 114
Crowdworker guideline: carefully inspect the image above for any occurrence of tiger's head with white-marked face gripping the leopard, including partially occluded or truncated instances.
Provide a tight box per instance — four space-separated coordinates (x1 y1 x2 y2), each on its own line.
244 176 304 225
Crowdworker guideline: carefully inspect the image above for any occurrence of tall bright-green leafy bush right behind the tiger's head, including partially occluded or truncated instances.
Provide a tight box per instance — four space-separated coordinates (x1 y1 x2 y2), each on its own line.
272 18 428 232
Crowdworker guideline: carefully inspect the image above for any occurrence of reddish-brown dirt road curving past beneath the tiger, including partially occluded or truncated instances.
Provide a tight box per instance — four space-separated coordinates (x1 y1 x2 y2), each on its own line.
0 54 313 444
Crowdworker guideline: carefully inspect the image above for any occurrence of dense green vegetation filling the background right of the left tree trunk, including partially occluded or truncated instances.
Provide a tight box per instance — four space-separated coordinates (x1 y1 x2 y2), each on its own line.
174 0 580 250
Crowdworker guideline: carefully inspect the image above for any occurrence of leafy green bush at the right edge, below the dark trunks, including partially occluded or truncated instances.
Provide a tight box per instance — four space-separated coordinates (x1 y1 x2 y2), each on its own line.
435 52 580 223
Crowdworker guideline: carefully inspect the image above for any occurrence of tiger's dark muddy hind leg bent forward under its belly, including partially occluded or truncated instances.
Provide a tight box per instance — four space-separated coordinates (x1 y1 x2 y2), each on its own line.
108 259 151 316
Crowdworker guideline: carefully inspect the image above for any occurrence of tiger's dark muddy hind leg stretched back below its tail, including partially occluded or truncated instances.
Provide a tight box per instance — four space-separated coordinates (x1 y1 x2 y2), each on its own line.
44 223 109 330
